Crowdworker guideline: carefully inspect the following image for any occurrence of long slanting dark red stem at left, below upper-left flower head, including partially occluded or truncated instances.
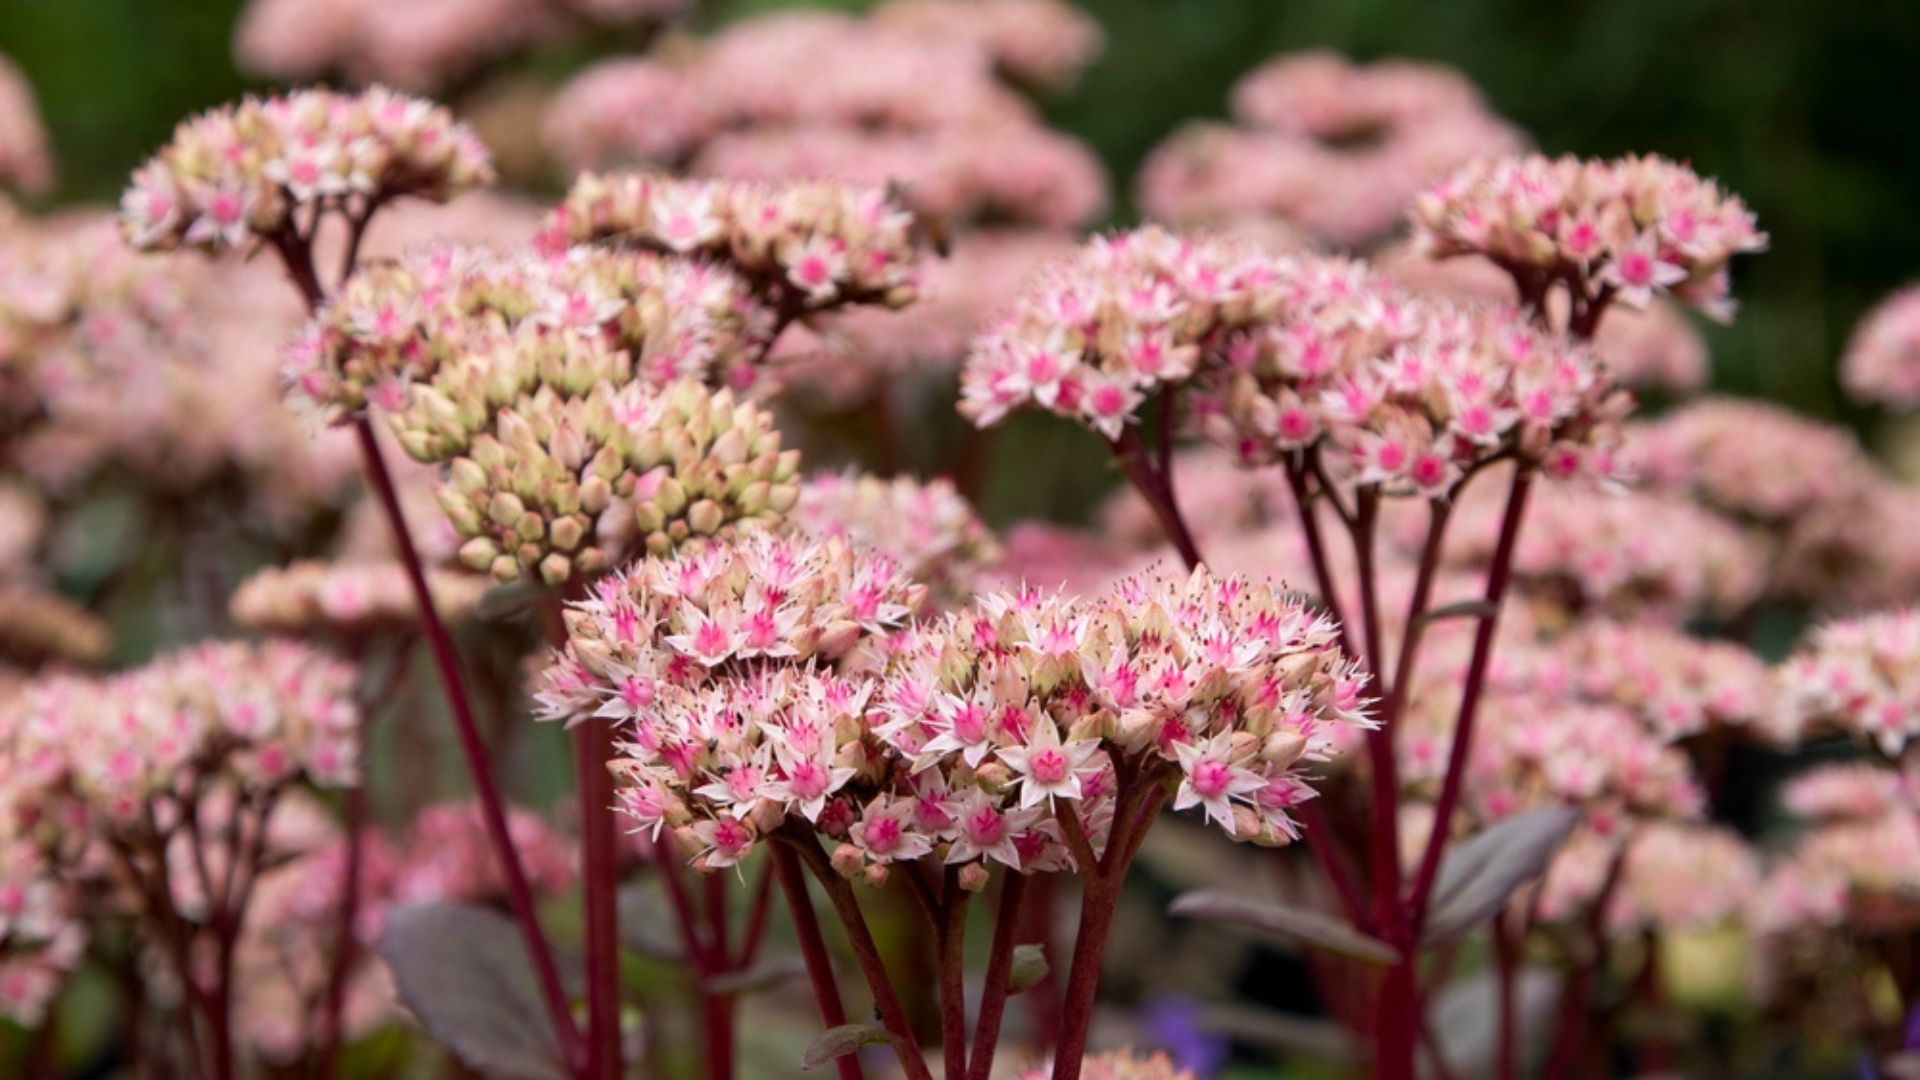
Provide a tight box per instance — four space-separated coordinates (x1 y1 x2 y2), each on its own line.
353 417 588 1076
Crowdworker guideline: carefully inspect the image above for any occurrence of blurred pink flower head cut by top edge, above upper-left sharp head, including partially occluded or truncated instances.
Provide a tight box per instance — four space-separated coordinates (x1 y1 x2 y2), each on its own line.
234 0 693 90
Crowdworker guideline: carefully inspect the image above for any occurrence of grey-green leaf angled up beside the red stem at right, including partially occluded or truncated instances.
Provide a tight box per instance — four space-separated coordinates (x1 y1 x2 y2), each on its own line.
1421 807 1580 945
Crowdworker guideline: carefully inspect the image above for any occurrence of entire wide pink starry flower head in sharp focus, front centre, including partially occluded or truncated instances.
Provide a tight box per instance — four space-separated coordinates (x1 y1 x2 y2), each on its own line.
541 538 1363 882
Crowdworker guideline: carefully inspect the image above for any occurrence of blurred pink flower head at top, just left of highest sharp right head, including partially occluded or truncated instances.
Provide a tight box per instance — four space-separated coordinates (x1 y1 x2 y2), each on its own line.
1140 52 1523 248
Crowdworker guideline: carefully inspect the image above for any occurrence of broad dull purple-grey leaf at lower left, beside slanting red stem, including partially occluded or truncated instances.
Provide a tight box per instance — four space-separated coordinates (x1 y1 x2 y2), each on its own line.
380 903 566 1080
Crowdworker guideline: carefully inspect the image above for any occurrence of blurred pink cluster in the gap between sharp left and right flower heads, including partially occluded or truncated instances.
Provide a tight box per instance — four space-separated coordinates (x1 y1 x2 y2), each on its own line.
768 229 1077 407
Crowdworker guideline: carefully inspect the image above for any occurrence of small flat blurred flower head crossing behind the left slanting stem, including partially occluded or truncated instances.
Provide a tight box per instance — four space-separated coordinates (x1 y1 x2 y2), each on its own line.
228 559 486 638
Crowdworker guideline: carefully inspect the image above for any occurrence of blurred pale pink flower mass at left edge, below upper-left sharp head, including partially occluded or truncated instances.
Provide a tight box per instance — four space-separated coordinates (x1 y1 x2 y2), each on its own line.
0 213 353 528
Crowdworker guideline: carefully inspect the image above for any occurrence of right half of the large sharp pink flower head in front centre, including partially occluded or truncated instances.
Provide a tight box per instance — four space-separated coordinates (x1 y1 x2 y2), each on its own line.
852 569 1367 872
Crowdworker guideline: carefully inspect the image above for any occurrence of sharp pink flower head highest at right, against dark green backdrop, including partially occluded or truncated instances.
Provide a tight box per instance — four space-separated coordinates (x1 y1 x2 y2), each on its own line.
1413 156 1766 319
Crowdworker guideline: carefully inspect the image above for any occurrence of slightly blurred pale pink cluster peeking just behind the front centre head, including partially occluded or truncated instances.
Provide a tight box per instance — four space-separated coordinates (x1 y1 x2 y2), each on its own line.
787 471 1000 603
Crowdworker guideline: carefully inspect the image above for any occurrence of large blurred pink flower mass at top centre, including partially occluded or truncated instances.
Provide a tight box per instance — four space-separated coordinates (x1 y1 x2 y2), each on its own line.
547 8 1106 229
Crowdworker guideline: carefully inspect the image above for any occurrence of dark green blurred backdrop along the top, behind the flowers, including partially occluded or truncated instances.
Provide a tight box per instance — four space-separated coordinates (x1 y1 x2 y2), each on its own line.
0 0 1920 421
